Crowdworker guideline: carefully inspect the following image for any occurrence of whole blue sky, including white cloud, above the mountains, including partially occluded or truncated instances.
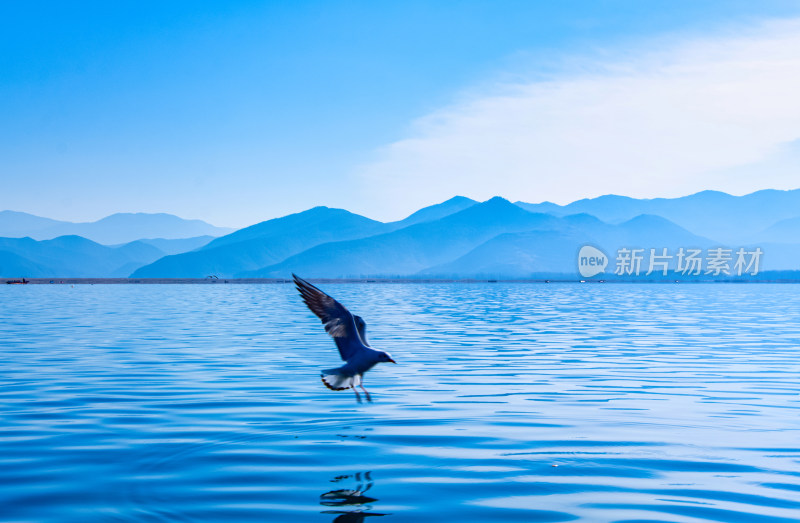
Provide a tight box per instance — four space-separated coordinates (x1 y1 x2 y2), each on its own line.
0 0 800 226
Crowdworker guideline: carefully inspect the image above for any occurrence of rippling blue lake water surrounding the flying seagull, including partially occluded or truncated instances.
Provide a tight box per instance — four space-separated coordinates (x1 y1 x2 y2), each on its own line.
0 283 800 523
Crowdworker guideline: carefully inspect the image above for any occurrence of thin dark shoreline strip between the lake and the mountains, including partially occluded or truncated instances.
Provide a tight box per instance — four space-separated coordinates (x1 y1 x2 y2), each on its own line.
6 277 800 285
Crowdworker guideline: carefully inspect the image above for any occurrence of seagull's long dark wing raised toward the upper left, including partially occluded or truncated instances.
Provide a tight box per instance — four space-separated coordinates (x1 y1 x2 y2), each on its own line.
292 274 364 361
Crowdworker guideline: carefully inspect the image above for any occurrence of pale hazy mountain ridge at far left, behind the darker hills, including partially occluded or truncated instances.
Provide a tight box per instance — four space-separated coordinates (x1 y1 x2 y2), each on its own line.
0 211 233 245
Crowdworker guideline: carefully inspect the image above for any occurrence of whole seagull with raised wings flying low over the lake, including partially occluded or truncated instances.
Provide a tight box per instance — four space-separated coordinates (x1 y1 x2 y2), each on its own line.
292 274 397 403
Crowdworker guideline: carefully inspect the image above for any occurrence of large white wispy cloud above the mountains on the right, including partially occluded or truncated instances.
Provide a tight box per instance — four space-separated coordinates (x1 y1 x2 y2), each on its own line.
357 20 800 218
